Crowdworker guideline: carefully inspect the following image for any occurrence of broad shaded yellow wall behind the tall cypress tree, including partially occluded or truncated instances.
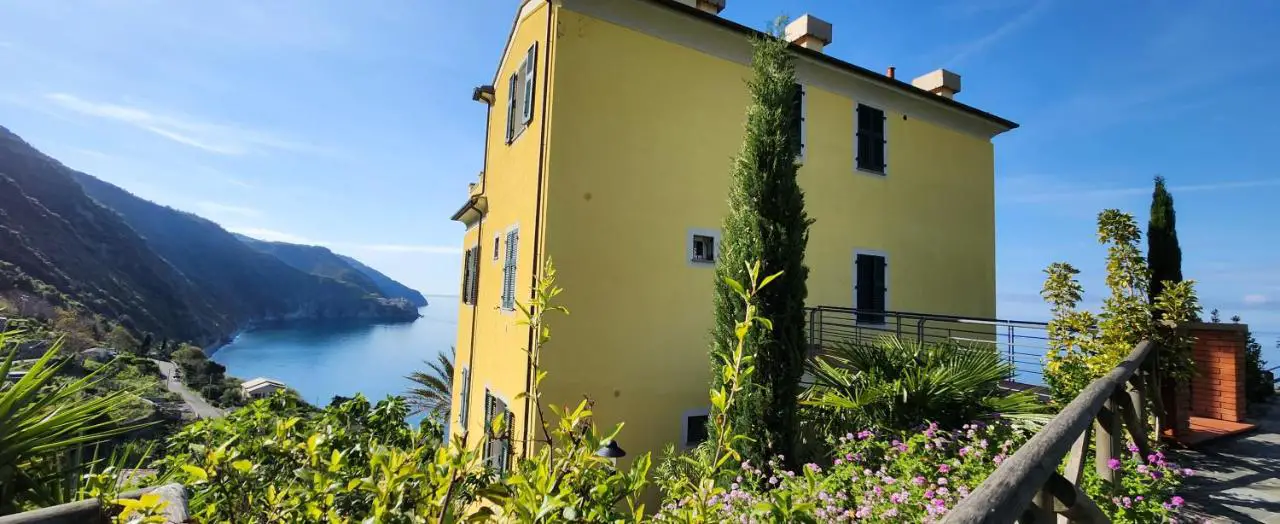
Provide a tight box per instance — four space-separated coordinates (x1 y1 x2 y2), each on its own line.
544 10 995 466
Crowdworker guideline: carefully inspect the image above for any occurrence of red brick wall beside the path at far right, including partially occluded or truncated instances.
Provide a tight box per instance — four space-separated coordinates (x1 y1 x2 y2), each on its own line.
1188 324 1247 422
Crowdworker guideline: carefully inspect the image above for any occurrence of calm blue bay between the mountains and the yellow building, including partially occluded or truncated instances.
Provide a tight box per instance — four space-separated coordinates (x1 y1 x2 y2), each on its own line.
212 306 458 406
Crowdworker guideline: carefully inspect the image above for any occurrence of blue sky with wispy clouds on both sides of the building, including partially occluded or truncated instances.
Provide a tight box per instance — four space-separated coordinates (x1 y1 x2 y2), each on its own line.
0 0 1280 346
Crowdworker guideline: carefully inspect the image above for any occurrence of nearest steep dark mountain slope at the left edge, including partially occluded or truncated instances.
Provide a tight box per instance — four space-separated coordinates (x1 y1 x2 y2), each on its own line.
0 127 222 340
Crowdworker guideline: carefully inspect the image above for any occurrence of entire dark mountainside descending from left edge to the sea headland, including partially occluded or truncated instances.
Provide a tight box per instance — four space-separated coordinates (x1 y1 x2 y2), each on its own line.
0 122 417 343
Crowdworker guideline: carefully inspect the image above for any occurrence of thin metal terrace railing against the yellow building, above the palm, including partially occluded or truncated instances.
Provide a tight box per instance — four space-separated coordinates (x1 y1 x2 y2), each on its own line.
805 306 1048 386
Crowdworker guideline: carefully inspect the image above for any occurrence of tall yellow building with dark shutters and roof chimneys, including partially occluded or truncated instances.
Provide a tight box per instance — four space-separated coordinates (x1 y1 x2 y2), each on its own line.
451 0 1016 466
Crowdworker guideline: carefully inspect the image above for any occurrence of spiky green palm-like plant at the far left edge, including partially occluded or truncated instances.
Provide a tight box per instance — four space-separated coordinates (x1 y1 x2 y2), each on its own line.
0 333 148 515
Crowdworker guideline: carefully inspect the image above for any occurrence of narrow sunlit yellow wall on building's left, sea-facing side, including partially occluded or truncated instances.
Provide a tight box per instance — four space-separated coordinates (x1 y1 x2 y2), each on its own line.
451 3 552 445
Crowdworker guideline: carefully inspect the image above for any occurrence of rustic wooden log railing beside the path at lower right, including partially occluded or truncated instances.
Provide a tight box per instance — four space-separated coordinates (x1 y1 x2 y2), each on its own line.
943 341 1161 524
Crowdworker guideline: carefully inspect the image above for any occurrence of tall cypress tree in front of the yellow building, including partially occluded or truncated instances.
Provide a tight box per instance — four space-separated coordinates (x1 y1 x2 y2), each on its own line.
712 22 812 464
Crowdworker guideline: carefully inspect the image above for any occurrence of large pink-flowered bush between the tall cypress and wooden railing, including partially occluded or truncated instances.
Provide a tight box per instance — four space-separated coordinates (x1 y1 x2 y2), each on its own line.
658 420 1029 523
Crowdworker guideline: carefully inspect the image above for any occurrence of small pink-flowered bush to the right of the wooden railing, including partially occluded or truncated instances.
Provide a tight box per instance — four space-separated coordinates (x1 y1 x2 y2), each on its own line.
1082 443 1194 523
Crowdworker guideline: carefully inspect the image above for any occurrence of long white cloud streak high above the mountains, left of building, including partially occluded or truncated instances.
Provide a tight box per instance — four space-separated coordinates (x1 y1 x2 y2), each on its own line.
44 92 324 156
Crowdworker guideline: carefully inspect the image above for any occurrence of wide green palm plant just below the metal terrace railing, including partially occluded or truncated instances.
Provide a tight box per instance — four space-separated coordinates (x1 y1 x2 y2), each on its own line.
801 337 1046 434
